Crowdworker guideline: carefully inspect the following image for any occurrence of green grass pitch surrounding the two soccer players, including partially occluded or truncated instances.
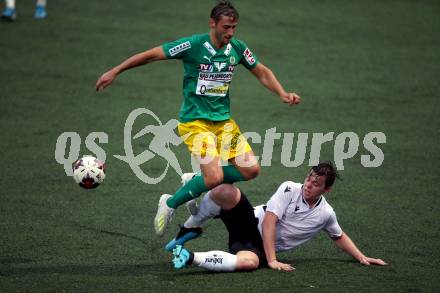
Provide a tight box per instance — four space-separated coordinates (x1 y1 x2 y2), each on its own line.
0 0 440 292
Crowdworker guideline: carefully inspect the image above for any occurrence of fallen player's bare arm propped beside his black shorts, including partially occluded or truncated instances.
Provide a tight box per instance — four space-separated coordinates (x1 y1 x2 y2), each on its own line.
263 212 295 272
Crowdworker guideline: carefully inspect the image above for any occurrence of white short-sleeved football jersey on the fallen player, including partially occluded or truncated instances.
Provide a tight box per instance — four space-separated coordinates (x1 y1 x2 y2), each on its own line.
255 181 342 251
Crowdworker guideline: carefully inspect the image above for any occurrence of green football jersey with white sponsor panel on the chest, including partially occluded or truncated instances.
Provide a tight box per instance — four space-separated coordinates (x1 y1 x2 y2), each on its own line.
162 33 258 122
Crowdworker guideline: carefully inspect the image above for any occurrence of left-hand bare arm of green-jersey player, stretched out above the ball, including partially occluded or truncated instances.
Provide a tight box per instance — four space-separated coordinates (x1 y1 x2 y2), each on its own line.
95 46 166 91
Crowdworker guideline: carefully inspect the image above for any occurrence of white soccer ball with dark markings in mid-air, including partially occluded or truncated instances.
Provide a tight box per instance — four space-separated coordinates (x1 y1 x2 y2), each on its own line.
73 156 105 189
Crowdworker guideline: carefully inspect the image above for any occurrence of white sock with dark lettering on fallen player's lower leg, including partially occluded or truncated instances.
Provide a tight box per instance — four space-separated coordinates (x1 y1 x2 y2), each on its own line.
193 250 237 272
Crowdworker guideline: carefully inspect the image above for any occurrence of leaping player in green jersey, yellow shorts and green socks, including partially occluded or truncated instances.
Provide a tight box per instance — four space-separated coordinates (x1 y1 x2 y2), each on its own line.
96 1 300 236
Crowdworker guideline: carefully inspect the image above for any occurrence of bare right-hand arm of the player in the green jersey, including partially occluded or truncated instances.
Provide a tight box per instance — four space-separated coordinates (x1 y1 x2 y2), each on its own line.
251 63 301 105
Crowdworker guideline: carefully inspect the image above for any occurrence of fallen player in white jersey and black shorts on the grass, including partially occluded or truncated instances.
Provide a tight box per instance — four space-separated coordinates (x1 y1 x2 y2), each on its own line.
166 163 387 271
